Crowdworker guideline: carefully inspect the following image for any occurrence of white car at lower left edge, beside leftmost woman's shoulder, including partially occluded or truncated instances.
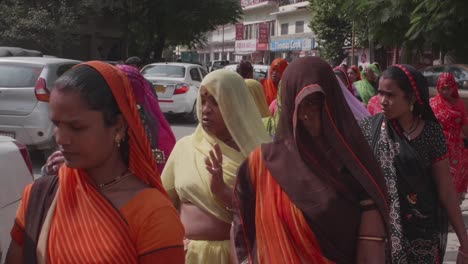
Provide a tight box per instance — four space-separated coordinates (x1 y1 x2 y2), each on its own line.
0 136 33 263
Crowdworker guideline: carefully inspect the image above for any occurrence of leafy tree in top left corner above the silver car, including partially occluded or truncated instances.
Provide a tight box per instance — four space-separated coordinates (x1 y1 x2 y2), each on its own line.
0 0 88 56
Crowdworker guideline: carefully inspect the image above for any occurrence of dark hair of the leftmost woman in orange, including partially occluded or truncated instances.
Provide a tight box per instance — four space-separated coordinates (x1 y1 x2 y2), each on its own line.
54 65 130 164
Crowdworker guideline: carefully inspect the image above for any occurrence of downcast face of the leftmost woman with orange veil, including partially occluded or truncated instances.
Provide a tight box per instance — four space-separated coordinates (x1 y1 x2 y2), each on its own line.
49 89 126 169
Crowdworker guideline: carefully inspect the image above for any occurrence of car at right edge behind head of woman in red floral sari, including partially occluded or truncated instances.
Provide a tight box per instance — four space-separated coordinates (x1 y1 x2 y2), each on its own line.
421 64 468 110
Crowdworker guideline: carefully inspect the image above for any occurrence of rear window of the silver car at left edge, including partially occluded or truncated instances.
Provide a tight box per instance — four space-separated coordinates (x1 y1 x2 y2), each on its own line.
0 64 42 88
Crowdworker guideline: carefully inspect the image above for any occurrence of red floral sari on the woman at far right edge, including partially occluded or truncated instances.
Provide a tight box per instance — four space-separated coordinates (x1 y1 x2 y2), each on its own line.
431 73 468 193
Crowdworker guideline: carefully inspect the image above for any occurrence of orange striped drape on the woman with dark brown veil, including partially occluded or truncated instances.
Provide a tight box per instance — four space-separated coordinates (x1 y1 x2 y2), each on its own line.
238 148 333 264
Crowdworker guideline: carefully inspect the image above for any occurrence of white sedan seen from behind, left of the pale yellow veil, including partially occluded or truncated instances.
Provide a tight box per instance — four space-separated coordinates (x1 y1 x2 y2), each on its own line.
141 63 208 122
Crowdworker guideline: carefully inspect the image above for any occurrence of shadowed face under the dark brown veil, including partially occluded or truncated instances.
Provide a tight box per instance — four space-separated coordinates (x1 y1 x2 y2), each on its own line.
297 92 324 137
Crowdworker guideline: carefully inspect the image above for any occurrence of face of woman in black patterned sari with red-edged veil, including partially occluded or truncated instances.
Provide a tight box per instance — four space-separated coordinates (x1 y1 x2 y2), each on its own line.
378 78 414 119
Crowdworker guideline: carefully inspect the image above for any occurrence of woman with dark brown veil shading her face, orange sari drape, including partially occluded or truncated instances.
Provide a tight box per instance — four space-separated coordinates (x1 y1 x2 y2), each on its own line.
233 57 388 263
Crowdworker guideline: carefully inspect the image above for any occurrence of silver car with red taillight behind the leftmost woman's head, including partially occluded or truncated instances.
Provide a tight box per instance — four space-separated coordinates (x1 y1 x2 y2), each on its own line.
0 57 79 156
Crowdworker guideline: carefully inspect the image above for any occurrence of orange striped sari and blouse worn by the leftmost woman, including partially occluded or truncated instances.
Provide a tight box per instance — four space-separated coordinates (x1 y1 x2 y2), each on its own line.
12 62 183 263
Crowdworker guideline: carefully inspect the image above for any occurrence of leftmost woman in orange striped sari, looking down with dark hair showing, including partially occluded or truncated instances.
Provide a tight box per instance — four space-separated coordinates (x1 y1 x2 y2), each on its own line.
7 62 184 264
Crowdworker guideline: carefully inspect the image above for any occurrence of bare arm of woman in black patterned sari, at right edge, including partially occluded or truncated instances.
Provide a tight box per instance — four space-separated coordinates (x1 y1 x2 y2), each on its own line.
432 159 468 253
